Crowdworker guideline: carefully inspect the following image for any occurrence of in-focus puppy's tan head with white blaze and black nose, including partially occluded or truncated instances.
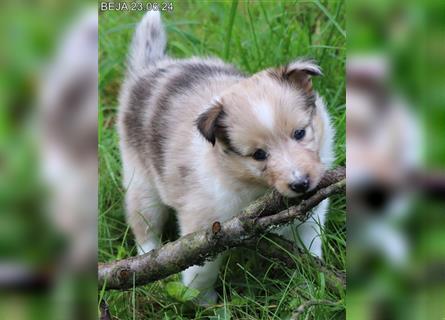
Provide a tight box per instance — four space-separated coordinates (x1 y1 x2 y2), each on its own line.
197 60 324 197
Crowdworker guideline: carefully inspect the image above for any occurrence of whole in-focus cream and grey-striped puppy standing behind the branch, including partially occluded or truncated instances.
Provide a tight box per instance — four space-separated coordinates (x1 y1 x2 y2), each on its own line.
119 12 334 303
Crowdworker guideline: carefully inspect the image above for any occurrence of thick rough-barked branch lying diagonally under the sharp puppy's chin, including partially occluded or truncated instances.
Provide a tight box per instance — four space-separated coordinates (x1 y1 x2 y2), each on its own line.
98 168 346 290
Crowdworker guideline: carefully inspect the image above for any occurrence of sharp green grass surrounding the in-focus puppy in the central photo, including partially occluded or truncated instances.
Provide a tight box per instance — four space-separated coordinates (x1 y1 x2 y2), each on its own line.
99 1 346 319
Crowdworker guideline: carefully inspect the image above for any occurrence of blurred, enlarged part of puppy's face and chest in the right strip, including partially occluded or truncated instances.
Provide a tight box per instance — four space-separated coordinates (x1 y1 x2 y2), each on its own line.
346 55 422 268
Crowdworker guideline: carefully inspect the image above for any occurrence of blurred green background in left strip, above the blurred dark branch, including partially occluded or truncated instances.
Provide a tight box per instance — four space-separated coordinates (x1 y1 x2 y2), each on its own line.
0 1 94 265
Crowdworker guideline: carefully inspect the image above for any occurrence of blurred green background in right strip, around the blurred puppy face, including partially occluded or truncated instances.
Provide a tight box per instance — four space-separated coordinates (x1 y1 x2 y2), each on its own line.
347 0 445 319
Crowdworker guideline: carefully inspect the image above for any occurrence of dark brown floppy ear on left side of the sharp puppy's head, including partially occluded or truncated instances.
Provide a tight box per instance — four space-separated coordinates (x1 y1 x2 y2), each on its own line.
196 101 224 145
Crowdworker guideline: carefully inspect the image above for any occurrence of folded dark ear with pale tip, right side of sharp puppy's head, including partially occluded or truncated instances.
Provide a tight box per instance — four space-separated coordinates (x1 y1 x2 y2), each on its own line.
272 60 322 94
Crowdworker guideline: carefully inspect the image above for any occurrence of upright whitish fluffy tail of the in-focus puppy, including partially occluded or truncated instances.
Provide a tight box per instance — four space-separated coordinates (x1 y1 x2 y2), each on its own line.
128 11 167 75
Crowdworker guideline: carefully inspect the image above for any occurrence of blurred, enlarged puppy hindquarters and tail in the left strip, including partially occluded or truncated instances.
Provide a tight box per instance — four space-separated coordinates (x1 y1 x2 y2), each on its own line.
38 9 98 272
